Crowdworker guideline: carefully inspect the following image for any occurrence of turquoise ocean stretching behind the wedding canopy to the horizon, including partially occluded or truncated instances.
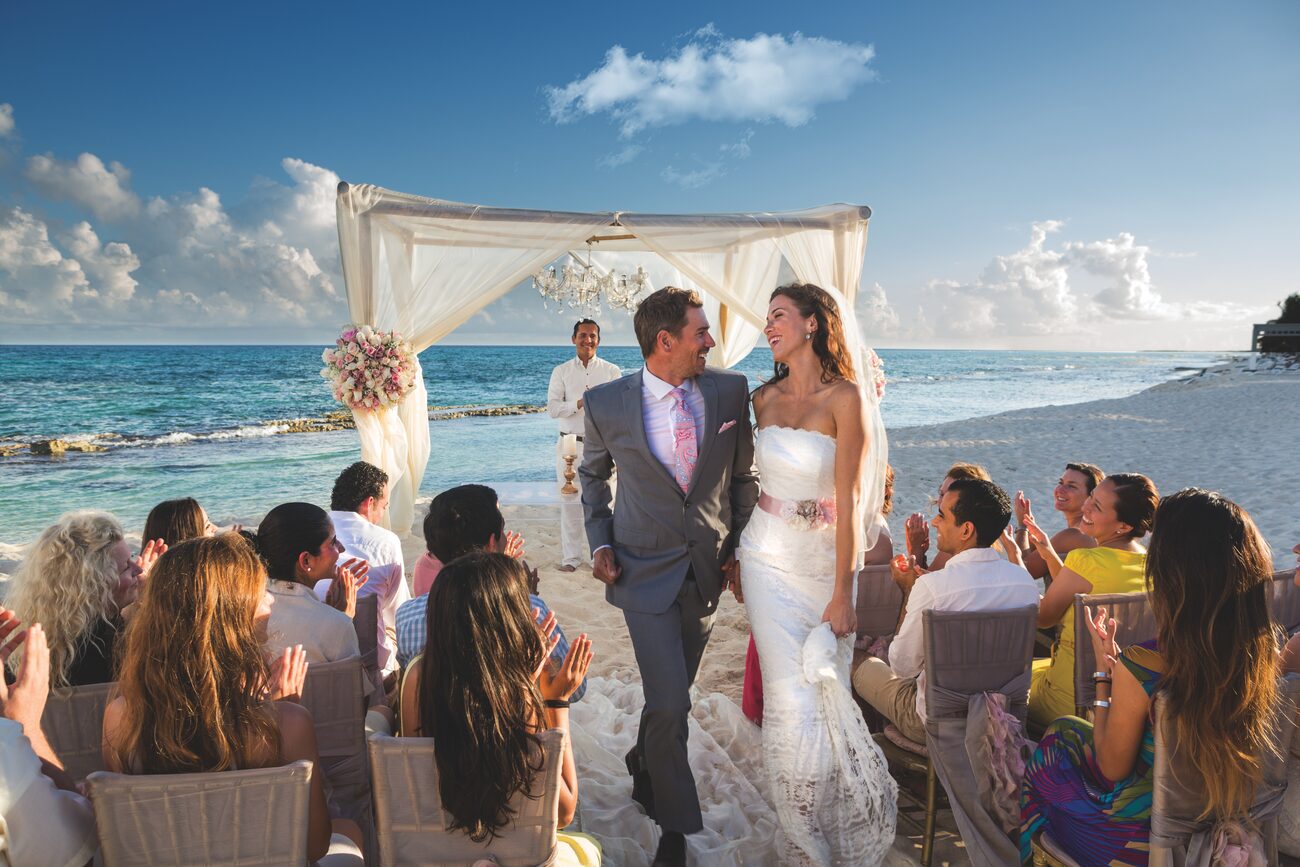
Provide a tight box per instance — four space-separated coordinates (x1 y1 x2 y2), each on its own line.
0 346 1217 543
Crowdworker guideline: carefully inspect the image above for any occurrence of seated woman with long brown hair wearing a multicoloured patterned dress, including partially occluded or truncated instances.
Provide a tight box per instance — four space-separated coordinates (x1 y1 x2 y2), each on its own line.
1021 491 1278 867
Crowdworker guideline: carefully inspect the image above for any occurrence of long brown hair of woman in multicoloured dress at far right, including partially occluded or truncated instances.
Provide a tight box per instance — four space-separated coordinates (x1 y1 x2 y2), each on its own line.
1147 487 1279 819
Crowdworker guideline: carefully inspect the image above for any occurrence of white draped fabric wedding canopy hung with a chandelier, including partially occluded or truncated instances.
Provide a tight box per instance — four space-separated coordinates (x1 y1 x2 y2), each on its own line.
337 182 871 536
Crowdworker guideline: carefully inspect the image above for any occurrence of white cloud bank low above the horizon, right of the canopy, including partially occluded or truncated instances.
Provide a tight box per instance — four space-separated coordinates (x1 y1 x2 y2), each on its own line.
859 220 1261 341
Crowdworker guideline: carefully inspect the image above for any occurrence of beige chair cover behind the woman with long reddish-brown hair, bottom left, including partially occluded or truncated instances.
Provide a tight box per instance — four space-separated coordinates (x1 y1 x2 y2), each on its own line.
88 760 312 867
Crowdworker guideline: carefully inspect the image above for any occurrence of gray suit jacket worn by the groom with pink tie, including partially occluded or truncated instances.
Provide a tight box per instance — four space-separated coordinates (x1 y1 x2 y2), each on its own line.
579 368 758 614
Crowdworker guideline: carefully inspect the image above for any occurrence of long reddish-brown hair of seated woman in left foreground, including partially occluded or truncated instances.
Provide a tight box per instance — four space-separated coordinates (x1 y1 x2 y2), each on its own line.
118 533 280 773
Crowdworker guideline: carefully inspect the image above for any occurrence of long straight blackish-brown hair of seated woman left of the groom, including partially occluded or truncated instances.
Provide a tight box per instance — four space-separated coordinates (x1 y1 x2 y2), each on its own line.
419 551 546 841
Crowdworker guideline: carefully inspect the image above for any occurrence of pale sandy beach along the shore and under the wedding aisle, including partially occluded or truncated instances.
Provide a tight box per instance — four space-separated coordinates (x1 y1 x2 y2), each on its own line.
0 365 1300 863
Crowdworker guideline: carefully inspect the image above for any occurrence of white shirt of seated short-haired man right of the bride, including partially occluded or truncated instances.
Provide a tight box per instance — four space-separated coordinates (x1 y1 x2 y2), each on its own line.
889 549 1039 721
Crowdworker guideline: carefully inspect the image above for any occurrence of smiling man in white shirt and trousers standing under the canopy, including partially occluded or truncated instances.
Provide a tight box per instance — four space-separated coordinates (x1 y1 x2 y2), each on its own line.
546 318 623 572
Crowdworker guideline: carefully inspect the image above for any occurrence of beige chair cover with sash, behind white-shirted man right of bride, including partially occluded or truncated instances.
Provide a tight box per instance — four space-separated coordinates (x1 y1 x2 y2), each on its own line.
922 606 1037 867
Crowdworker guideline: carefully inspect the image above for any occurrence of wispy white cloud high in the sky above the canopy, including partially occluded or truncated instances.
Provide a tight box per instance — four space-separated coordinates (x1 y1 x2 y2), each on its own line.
545 26 876 138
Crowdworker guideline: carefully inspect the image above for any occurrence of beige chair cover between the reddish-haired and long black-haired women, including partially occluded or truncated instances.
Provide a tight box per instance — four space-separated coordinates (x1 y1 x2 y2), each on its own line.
302 656 373 838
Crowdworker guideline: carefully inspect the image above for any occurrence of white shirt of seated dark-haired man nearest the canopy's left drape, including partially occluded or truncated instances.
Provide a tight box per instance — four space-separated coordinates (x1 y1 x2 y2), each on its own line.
316 512 411 675
